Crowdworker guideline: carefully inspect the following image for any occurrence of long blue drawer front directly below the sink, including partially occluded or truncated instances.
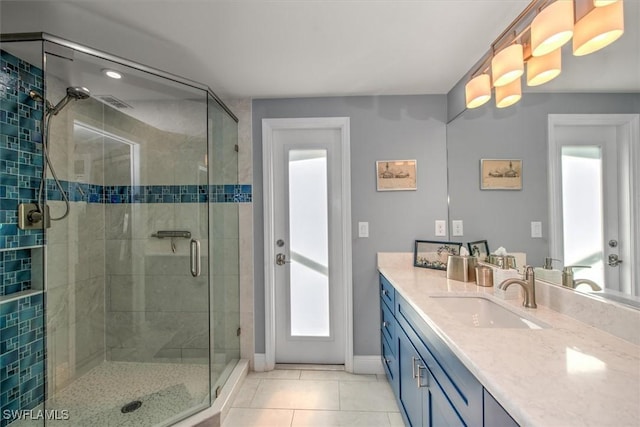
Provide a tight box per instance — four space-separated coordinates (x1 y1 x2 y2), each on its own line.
396 295 483 425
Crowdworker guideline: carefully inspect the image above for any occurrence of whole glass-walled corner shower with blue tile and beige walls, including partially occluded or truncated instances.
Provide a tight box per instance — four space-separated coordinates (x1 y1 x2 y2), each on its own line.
0 34 241 427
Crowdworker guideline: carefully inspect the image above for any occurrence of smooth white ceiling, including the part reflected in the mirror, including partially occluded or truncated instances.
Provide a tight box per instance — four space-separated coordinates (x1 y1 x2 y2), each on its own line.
0 0 640 98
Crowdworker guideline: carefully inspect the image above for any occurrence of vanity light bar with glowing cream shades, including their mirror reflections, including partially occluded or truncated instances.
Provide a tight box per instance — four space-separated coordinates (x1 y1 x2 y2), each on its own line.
465 0 624 108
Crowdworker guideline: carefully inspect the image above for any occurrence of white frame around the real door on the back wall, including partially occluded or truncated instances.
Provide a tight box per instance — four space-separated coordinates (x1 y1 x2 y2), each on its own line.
262 117 353 372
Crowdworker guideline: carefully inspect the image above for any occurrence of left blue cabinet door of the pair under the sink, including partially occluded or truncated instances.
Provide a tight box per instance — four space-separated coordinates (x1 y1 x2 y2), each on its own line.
396 330 429 427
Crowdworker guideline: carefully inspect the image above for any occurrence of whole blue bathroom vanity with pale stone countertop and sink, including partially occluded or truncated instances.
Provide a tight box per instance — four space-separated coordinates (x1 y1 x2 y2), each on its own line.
378 253 640 426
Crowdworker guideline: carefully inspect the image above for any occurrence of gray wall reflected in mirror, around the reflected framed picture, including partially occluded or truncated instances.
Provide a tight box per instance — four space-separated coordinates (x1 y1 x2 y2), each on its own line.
447 93 640 266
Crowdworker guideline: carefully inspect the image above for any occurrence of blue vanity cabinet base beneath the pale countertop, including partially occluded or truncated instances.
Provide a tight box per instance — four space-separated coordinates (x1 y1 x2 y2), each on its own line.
380 274 518 427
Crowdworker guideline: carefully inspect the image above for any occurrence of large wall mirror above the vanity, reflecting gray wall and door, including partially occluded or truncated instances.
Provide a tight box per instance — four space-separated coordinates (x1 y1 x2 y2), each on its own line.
447 2 640 308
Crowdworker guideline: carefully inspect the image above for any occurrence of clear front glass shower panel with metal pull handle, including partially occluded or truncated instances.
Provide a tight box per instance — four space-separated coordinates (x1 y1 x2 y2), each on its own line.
46 43 211 426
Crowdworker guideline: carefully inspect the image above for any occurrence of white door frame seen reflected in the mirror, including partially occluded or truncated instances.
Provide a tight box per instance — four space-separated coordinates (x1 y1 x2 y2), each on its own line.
547 114 640 295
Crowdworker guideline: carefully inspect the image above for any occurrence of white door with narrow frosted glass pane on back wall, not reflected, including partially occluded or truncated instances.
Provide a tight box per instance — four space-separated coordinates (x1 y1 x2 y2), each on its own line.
263 119 351 364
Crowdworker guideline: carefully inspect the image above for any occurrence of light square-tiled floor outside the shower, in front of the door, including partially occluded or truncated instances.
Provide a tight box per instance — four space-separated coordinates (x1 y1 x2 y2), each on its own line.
222 369 404 427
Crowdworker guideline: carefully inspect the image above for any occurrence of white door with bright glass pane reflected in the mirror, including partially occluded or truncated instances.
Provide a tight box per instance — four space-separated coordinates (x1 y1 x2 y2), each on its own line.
550 114 637 295
